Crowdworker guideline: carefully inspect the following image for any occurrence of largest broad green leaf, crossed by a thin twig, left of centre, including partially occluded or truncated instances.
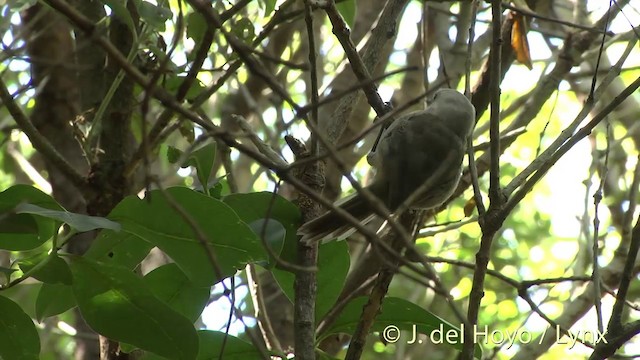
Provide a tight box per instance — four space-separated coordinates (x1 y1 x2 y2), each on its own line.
109 187 266 286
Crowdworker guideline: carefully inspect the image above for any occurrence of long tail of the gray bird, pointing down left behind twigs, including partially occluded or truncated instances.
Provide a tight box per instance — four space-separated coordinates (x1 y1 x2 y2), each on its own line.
298 183 386 244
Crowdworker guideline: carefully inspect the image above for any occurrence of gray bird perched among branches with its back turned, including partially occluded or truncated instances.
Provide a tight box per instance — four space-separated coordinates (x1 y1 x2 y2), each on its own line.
298 89 475 243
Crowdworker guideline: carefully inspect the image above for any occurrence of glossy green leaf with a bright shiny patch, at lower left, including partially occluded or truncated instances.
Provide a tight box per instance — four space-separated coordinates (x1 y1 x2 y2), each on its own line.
71 257 198 359
